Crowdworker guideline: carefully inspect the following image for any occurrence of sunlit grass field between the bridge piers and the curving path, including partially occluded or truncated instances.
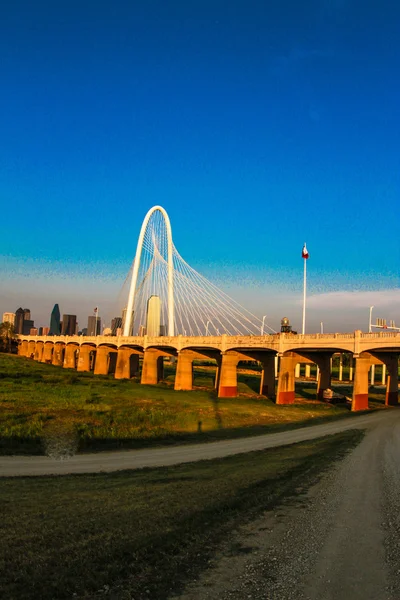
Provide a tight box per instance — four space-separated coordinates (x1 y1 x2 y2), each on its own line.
0 354 384 454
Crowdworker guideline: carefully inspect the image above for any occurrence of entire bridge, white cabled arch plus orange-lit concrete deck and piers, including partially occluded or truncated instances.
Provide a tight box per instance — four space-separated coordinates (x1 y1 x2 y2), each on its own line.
19 206 400 410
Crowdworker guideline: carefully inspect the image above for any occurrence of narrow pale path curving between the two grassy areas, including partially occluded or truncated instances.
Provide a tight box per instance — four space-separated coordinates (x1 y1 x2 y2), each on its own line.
0 410 387 477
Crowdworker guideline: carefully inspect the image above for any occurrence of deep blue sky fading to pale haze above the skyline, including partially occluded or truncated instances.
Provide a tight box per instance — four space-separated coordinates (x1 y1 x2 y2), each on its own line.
0 0 400 328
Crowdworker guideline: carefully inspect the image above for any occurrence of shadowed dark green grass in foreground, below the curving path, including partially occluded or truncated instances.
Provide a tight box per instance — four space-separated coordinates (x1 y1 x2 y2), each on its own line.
0 431 363 600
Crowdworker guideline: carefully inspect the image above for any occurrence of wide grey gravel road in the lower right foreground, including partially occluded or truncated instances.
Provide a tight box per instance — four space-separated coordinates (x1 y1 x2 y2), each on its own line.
175 411 400 600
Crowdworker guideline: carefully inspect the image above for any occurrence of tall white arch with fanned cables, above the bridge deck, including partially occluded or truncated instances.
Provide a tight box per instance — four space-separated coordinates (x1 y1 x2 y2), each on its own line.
117 206 276 336
